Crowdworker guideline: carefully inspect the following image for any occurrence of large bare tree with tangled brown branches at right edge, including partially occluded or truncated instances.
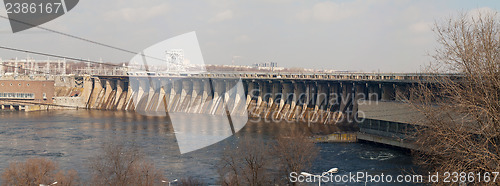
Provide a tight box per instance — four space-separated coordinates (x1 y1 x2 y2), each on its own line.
412 9 500 181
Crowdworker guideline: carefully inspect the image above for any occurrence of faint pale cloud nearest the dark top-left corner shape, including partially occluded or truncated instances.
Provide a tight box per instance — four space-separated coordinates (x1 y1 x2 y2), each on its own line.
105 3 170 22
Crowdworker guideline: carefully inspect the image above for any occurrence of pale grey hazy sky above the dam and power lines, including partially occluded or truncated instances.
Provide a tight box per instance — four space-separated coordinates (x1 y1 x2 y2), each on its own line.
0 0 500 72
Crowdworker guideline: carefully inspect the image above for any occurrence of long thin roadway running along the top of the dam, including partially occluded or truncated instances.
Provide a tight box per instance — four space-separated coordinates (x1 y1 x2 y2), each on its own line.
93 72 462 83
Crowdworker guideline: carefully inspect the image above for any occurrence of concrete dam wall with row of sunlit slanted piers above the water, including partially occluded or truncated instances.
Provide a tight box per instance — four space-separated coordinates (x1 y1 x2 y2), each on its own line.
80 77 406 124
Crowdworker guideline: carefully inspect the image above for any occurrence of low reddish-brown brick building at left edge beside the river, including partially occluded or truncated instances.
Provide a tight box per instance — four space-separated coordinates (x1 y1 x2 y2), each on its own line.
0 80 55 110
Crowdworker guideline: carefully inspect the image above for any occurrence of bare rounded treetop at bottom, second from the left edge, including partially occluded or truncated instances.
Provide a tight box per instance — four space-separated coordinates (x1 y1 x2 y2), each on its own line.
90 142 165 186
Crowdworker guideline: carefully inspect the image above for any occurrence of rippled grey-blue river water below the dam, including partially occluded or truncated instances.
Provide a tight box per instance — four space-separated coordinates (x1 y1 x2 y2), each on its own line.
0 110 415 185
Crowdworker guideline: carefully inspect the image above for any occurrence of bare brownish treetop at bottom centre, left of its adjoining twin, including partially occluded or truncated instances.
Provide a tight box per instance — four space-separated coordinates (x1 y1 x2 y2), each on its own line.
218 137 273 186
